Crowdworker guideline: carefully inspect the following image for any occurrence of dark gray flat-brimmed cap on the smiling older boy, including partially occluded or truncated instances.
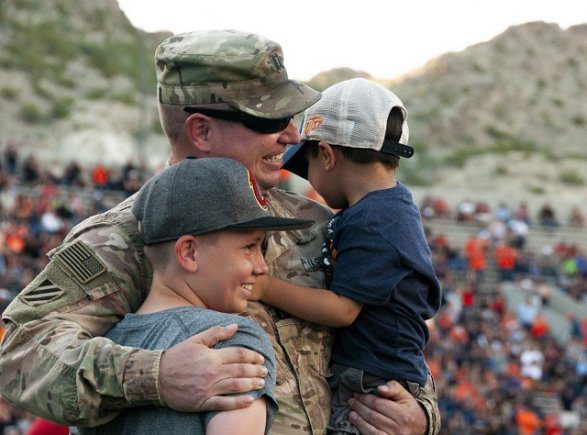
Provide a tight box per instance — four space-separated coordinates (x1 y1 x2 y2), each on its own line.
132 157 314 245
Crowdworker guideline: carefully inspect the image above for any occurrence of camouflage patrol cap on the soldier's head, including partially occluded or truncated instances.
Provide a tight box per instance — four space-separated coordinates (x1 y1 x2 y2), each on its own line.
155 30 320 118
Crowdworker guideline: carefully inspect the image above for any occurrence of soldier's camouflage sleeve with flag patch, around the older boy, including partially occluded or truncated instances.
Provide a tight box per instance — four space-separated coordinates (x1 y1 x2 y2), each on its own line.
0 198 161 426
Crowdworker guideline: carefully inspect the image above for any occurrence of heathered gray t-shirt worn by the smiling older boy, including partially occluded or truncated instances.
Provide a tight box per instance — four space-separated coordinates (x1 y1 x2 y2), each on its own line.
80 307 277 435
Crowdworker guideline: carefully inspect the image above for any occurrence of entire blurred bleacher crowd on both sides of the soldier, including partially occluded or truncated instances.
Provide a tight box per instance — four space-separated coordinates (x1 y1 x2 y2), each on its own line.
0 147 587 434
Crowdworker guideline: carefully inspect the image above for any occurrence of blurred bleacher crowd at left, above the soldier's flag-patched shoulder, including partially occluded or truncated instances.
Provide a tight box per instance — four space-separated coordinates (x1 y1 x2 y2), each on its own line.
0 146 150 293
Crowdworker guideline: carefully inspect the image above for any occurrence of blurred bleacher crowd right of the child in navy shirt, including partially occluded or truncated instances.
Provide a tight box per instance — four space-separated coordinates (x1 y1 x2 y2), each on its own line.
421 198 587 434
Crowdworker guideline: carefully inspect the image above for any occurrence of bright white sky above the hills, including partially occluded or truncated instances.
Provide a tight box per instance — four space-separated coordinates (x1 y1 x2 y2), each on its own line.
118 0 587 80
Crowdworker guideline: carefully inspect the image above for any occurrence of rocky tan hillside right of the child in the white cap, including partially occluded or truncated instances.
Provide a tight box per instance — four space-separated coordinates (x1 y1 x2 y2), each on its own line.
388 22 587 209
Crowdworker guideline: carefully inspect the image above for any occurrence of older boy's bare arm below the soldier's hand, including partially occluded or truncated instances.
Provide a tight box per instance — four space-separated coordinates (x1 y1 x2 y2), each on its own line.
206 398 267 435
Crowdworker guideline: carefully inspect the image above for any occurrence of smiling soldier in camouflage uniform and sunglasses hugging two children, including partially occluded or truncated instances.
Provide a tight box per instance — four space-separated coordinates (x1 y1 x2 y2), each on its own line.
0 31 439 434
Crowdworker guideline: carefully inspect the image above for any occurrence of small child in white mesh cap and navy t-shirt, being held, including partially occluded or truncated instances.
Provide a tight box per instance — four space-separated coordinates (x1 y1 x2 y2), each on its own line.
253 79 441 434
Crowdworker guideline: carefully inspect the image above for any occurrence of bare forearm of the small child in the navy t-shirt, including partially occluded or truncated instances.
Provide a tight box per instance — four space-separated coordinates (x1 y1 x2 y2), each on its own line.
251 276 363 328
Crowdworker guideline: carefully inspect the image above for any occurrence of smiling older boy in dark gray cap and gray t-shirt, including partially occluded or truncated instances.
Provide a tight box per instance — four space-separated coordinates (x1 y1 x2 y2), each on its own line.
82 158 312 434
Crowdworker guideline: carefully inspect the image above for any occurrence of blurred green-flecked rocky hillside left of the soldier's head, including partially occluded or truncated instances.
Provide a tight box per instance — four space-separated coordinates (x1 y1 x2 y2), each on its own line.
0 0 167 164
